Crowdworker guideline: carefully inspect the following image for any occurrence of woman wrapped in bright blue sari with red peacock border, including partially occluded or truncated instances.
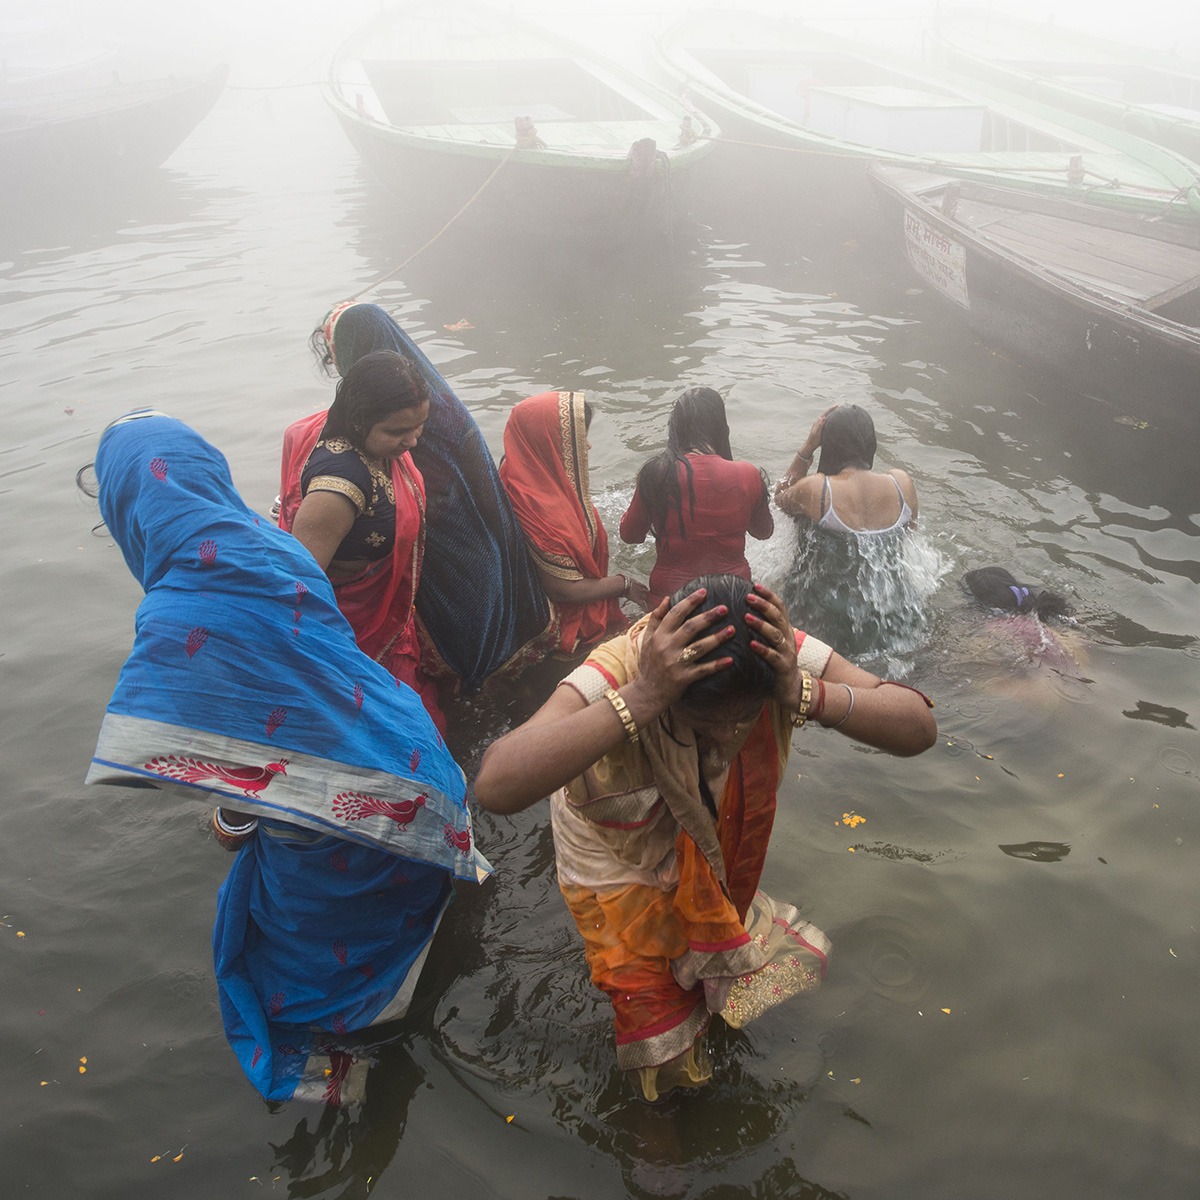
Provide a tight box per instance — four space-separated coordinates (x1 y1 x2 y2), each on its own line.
88 413 491 1103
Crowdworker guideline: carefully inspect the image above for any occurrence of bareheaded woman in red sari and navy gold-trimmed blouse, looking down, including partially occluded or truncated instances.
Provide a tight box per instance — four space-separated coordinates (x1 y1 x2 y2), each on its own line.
280 350 444 727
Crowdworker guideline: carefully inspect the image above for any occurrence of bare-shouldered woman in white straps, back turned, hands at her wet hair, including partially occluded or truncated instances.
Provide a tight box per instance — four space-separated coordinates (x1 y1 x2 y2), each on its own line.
775 404 917 535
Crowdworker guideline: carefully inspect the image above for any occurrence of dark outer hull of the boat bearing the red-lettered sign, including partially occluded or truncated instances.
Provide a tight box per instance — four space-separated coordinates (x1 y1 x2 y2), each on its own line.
869 172 1200 434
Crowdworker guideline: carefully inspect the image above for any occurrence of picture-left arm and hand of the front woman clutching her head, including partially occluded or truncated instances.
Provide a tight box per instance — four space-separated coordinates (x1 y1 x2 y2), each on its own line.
475 590 733 812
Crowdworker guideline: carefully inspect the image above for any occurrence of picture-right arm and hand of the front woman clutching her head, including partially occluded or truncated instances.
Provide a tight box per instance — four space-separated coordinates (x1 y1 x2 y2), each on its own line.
746 583 937 757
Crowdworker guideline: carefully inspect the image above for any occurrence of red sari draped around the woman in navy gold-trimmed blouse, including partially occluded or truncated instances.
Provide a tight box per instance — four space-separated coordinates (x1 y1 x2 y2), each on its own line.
280 412 445 731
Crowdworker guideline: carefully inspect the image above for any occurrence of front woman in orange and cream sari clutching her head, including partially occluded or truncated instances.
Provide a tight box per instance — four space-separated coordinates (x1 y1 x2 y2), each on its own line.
475 575 937 1102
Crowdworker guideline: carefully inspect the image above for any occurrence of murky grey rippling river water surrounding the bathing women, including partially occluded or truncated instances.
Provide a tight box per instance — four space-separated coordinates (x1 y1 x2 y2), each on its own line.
7 25 1200 1200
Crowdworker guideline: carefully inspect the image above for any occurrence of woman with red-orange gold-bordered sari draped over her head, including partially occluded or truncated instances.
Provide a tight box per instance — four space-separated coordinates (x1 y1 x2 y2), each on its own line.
500 391 649 654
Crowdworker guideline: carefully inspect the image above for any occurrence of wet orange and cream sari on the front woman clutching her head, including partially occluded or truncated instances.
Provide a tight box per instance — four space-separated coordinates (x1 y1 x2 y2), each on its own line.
551 619 829 1100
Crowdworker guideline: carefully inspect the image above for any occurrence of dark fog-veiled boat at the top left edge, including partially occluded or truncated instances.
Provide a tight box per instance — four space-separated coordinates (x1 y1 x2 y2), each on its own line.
0 66 228 191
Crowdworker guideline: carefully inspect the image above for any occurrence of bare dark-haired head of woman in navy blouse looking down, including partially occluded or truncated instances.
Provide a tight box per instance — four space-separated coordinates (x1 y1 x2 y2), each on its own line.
323 350 430 458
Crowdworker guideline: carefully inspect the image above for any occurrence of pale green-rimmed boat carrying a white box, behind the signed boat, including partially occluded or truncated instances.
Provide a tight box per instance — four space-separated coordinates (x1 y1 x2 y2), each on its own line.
658 12 1200 220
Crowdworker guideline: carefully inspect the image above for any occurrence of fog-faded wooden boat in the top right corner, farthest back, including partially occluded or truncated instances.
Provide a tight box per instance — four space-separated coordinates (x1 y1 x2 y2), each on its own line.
931 8 1200 161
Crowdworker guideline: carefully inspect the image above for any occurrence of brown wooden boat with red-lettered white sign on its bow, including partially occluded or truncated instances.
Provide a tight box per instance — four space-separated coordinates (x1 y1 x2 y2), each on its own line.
868 164 1200 433
